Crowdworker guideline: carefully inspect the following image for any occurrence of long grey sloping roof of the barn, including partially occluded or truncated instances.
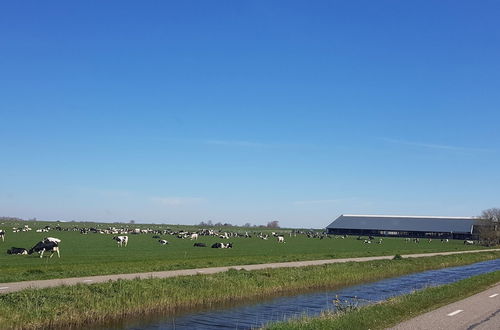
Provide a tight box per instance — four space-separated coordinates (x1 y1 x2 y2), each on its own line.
326 214 475 233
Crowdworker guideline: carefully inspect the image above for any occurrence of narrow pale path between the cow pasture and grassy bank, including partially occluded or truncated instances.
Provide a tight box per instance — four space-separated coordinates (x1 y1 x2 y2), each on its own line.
0 249 500 294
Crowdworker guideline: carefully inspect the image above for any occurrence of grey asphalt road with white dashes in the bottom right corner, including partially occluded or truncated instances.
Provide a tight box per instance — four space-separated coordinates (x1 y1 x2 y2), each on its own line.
391 283 500 330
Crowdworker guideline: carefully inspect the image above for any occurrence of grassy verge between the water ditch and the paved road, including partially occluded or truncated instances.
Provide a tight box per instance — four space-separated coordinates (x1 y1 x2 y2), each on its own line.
266 271 500 330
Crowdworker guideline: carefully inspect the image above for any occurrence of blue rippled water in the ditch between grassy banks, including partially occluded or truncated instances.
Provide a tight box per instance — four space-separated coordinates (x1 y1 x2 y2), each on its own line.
107 259 500 330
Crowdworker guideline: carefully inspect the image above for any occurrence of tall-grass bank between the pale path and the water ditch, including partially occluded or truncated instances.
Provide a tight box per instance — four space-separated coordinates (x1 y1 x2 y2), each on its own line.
0 252 500 328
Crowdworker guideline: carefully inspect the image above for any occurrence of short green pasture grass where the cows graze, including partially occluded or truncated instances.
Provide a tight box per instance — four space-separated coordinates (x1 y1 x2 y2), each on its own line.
0 222 490 282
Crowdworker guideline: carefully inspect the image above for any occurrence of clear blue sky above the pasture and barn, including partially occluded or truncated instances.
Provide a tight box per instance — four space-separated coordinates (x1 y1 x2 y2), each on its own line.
0 0 500 227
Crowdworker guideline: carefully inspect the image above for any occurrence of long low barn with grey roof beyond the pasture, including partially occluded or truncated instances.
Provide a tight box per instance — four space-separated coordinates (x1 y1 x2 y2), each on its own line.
326 214 476 239
